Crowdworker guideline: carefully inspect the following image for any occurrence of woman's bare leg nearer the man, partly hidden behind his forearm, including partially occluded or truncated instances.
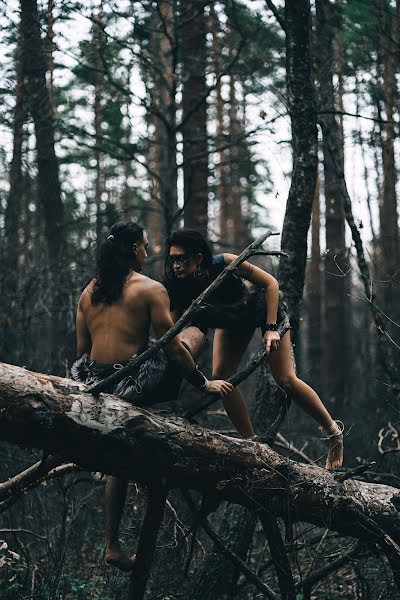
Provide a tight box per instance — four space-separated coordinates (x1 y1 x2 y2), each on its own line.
212 329 254 439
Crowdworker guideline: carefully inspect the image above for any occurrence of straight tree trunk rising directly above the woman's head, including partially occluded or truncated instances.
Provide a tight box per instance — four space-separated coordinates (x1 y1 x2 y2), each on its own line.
181 0 208 237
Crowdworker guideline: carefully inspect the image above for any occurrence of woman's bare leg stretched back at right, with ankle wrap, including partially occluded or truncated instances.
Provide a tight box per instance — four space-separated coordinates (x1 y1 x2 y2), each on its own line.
269 331 343 470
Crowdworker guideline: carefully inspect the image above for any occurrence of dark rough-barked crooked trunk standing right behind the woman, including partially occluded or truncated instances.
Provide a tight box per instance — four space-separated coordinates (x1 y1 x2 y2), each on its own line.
278 0 318 342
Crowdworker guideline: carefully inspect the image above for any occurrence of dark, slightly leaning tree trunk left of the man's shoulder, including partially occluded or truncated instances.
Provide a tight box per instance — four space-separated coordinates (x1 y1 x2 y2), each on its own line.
21 0 72 369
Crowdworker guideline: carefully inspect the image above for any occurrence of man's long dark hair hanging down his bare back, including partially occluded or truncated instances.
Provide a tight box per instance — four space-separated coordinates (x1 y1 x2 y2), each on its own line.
92 221 143 305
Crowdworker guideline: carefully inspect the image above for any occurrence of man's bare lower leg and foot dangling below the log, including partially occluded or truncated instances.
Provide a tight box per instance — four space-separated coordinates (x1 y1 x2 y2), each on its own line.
104 476 135 571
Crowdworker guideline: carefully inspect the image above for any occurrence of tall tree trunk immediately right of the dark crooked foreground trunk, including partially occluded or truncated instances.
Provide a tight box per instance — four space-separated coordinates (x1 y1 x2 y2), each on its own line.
316 0 347 409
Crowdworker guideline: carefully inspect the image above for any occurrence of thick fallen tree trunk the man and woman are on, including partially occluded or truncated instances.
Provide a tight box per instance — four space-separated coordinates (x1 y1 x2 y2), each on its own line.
0 364 400 548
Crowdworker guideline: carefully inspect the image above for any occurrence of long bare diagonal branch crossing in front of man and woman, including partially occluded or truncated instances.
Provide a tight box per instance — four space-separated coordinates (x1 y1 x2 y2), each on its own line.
87 229 278 395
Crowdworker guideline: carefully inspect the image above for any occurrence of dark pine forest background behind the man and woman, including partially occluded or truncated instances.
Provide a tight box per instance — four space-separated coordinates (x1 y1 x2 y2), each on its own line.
0 0 400 600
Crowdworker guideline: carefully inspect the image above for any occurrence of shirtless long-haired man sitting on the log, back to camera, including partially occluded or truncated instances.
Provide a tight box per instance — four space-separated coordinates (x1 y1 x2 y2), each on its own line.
71 222 233 571
